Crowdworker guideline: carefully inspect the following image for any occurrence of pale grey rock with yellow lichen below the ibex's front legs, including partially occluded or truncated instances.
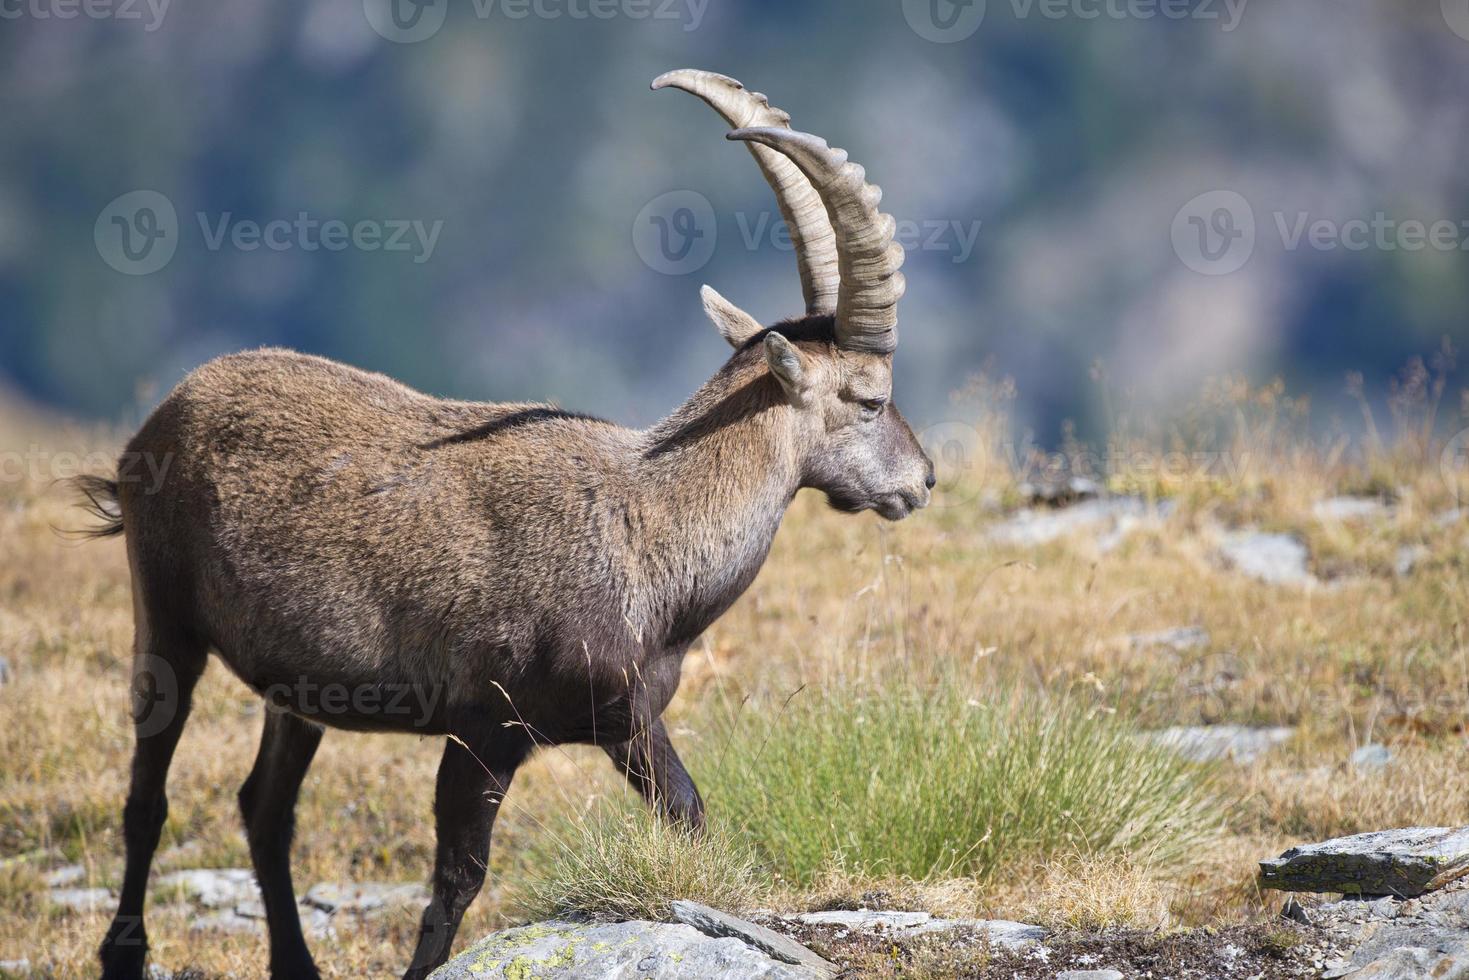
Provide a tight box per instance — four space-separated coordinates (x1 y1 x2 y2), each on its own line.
432 921 818 980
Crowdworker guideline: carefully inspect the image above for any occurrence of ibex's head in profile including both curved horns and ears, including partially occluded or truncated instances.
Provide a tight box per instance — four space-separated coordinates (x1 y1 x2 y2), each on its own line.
652 69 934 520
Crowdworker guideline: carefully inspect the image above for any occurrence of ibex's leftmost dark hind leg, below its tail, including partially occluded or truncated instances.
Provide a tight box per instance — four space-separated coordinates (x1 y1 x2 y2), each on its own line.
100 608 207 980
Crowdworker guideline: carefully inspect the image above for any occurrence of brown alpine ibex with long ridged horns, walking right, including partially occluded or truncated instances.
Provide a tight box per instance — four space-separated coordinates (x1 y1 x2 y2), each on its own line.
82 69 934 979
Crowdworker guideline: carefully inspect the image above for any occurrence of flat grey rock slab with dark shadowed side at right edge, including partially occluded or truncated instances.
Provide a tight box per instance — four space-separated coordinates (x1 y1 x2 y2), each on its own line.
1260 827 1469 896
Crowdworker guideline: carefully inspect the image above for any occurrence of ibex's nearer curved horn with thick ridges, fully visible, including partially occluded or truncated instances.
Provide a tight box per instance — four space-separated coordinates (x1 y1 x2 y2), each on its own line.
727 126 905 354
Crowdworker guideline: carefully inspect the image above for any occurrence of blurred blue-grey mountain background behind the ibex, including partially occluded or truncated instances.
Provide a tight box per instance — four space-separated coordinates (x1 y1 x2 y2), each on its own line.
0 0 1469 442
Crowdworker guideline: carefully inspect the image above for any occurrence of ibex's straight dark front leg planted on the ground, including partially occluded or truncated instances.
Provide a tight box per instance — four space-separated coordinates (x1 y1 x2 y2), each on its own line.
403 733 527 980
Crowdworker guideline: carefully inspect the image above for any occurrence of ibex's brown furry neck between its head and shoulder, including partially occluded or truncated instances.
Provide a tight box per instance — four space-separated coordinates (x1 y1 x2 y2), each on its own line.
633 366 801 645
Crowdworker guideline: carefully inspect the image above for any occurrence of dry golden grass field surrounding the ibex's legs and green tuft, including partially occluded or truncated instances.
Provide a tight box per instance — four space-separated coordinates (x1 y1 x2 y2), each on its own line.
0 362 1469 977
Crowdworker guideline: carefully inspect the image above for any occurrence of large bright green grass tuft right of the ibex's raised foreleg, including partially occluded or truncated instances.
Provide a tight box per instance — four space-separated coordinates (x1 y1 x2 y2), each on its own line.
698 683 1221 883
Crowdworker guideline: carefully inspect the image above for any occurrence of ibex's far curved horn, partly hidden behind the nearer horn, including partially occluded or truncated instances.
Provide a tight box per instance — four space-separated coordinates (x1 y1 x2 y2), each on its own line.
652 68 840 313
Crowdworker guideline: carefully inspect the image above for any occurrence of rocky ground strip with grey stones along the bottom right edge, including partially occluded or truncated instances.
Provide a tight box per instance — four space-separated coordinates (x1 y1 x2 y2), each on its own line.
423 827 1469 980
